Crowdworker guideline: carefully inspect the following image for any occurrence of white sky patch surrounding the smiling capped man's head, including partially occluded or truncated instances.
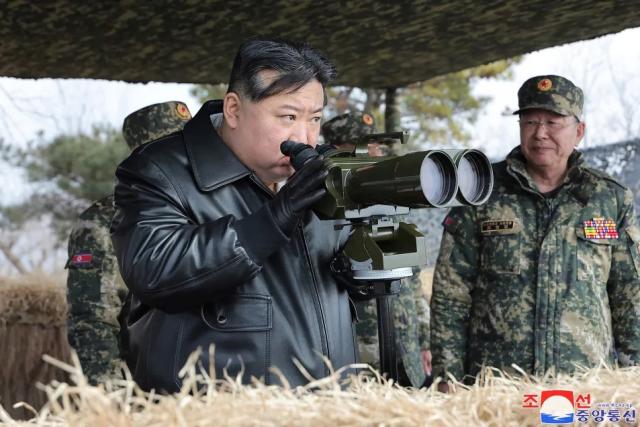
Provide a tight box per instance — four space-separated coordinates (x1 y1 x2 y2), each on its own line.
472 28 640 158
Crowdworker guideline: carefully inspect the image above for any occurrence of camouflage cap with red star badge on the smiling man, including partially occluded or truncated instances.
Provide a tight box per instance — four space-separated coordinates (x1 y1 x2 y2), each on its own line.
513 75 584 120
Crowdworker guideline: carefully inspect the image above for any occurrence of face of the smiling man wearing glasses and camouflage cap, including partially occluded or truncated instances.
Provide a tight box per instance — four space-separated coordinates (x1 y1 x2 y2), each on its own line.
520 110 585 173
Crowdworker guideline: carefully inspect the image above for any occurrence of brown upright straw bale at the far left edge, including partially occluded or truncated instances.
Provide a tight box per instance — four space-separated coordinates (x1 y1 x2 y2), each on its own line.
0 273 69 418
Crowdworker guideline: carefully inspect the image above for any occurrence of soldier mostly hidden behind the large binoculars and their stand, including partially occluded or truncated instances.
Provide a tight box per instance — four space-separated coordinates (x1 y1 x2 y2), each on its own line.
322 112 431 387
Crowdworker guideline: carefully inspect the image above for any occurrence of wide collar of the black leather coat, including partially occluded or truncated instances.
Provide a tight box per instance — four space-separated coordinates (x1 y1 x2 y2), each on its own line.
183 100 251 191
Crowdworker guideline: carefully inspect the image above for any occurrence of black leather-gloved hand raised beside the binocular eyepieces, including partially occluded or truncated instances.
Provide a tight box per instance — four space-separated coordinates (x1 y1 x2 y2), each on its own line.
269 141 328 236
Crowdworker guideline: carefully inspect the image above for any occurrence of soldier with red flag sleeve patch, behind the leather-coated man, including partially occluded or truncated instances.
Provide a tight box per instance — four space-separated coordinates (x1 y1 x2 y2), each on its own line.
66 101 191 383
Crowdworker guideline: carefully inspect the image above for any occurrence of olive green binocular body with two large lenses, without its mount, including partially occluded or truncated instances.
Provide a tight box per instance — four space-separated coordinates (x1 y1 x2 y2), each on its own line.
314 132 493 219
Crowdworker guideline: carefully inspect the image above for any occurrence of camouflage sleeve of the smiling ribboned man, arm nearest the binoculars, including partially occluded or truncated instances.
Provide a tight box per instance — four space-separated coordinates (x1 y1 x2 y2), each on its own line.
431 208 479 379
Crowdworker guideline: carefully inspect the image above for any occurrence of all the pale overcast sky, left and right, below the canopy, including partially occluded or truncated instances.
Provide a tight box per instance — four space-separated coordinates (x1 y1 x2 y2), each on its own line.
0 28 640 206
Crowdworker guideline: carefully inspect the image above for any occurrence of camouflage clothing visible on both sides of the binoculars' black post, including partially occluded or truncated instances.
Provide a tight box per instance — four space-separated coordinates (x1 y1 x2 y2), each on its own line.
356 273 429 387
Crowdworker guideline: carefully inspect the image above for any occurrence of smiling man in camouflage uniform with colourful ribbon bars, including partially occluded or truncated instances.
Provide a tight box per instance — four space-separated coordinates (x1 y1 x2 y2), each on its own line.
431 75 640 390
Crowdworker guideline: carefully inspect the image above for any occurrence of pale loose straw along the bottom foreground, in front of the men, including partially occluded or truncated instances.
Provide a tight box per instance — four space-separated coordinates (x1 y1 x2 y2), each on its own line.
0 352 640 427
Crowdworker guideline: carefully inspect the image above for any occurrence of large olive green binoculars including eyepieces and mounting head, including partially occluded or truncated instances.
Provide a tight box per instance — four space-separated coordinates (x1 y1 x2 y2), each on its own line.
281 132 493 280
